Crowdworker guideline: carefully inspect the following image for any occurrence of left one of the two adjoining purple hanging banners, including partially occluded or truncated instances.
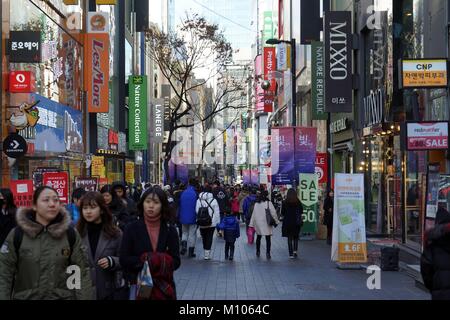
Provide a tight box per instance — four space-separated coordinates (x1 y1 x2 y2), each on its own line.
272 128 295 185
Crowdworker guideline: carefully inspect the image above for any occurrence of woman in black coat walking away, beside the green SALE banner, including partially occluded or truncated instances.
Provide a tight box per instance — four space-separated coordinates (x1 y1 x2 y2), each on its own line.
281 189 303 259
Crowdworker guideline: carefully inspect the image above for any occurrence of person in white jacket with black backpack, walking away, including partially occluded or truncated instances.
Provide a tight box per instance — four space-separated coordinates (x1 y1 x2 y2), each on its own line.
195 186 220 260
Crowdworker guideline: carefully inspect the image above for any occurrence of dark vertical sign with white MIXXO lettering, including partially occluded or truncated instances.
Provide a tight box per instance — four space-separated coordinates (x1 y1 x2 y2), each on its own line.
325 11 353 113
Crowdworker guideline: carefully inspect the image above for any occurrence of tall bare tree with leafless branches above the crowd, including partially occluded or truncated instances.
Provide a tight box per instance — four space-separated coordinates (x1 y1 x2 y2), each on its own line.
145 15 248 182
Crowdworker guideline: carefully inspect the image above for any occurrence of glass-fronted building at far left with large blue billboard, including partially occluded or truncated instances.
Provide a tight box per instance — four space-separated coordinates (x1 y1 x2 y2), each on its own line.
1 0 86 192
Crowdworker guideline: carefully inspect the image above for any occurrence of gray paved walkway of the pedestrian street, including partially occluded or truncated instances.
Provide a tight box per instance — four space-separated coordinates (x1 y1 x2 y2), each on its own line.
175 224 430 300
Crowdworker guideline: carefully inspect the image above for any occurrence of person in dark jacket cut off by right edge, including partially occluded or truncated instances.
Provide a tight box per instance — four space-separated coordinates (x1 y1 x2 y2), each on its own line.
420 204 450 300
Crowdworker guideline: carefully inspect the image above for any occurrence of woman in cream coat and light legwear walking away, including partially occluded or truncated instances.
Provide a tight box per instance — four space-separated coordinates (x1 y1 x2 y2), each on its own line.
249 191 280 260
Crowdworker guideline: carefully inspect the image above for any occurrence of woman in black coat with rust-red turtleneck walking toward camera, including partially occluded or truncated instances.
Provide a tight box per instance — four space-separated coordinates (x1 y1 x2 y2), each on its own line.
120 187 181 300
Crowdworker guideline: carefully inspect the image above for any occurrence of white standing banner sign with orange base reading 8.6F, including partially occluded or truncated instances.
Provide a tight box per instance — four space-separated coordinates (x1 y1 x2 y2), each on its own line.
331 173 367 263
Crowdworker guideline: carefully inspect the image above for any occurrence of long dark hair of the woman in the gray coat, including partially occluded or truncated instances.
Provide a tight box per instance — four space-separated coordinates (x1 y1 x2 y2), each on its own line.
77 191 119 239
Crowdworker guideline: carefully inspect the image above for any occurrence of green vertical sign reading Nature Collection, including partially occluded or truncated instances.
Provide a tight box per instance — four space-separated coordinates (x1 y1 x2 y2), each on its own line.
128 76 148 150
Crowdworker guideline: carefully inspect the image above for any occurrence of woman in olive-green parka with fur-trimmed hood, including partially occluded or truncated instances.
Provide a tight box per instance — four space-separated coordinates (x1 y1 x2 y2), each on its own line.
0 186 92 300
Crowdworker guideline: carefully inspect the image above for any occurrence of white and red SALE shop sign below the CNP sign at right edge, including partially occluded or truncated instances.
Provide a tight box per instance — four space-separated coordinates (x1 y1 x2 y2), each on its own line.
406 122 449 151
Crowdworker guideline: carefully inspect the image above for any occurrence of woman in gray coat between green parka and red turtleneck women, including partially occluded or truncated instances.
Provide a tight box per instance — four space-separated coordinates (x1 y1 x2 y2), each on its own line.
77 192 128 300
